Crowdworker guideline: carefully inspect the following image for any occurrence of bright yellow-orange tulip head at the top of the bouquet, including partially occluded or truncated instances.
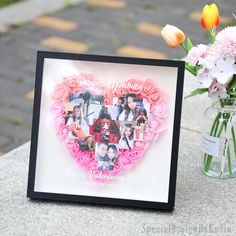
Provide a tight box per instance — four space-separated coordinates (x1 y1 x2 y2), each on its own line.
201 3 219 30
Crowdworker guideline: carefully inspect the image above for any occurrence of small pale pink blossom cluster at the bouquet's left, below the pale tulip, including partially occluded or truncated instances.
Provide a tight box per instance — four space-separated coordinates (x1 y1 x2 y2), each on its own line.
186 44 208 66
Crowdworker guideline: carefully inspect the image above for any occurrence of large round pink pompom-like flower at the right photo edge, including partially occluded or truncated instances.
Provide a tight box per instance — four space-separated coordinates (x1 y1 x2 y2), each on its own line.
213 26 236 59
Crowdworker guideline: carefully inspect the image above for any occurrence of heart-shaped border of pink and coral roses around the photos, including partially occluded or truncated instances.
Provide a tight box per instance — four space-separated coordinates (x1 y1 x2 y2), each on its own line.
50 74 166 182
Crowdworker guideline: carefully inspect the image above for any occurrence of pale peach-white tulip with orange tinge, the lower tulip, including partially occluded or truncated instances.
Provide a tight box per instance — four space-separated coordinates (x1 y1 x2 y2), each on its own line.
161 25 185 48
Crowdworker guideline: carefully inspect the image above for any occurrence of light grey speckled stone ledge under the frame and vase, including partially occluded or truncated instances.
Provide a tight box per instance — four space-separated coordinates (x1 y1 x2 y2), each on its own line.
0 129 236 236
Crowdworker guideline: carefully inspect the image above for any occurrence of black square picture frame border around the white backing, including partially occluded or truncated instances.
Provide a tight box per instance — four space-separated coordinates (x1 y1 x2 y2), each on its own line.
27 51 184 211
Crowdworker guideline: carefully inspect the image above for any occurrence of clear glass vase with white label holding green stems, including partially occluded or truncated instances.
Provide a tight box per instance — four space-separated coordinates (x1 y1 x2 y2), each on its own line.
201 98 236 179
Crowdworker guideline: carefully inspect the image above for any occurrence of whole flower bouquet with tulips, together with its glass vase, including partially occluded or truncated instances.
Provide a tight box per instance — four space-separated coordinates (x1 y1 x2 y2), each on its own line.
161 3 236 178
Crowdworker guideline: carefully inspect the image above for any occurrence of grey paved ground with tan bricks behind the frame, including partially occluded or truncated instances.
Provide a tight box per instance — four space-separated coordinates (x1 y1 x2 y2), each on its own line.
0 0 235 155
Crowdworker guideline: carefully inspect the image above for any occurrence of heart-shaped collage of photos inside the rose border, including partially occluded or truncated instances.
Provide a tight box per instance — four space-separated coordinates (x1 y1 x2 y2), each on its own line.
65 90 150 170
